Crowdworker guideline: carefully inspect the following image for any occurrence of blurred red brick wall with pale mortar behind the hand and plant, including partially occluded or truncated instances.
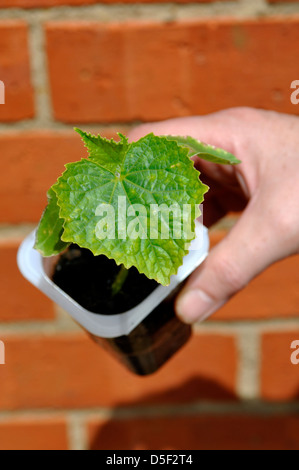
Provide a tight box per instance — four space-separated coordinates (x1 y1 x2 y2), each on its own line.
0 0 299 449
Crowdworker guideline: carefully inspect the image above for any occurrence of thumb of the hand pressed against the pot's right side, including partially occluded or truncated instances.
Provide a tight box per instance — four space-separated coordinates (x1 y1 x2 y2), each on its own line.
176 200 278 323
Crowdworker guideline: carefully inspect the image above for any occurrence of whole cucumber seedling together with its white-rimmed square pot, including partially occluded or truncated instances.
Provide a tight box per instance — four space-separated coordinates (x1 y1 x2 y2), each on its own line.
23 129 239 375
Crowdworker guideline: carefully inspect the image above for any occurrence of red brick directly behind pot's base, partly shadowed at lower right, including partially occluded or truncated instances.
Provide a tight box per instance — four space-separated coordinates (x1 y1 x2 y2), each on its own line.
0 334 237 410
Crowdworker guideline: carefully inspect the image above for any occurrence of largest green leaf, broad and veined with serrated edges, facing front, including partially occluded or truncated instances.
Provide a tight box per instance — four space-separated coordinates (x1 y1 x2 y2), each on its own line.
53 131 208 285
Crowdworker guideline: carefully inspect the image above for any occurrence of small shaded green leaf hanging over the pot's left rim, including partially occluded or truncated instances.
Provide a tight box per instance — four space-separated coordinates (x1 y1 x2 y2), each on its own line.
34 189 69 257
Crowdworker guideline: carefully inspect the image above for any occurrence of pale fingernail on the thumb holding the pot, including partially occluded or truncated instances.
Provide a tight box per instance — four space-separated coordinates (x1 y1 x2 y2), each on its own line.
176 289 217 323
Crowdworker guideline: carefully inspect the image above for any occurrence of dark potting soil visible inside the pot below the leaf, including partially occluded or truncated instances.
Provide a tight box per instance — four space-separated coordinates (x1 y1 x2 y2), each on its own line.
53 245 158 315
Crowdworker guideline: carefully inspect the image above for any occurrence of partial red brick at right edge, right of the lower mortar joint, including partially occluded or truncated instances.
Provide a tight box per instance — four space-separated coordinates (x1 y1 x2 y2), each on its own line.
261 329 299 401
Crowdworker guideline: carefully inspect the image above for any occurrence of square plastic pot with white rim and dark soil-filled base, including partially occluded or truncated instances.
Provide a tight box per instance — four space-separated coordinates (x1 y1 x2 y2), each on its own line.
18 223 209 375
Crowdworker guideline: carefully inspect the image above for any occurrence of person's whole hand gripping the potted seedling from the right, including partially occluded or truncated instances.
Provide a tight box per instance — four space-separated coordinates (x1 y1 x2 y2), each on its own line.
129 108 299 323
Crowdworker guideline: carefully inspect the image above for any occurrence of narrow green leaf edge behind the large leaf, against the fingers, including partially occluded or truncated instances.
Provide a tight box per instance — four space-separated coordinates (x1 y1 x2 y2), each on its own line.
167 136 241 165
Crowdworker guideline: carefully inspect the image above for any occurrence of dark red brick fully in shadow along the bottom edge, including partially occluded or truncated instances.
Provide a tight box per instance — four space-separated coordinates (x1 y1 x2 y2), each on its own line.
89 415 299 453
